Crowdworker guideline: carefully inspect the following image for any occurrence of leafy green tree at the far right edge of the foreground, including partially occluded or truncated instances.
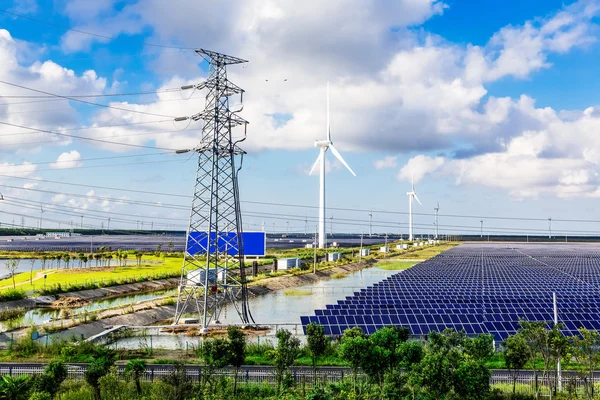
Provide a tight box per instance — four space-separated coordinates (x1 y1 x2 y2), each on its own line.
571 328 600 400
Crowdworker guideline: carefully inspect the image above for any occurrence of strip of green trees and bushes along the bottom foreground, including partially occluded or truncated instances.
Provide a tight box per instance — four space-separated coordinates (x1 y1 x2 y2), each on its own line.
0 321 600 400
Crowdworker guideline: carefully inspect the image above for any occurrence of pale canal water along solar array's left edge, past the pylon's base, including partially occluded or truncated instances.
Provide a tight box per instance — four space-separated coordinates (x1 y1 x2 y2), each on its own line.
113 267 401 349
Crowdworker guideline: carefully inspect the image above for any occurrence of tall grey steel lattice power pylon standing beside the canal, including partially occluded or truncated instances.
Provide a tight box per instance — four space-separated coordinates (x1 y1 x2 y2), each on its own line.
173 49 253 332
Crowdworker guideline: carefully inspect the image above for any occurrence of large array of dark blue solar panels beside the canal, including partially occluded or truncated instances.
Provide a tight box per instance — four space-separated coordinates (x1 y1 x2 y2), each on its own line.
301 243 600 340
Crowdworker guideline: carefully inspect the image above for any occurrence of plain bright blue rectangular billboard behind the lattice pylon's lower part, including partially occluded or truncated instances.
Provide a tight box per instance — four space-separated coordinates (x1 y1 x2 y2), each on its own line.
186 232 267 257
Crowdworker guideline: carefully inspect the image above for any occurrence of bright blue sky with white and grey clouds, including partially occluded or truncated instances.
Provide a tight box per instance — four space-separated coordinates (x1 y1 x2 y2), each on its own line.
0 0 600 236
